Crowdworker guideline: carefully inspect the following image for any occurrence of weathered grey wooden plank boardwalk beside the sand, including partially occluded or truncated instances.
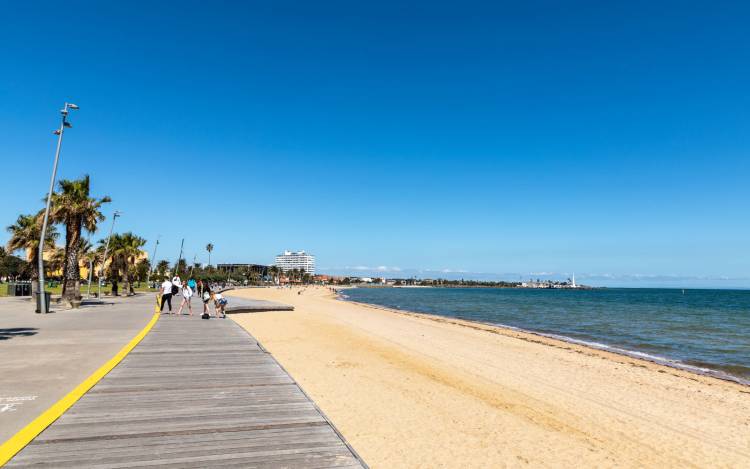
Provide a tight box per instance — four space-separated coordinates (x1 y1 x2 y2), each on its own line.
8 307 364 468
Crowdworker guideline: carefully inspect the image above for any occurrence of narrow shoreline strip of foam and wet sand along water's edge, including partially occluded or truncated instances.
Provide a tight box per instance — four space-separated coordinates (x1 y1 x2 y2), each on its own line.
334 293 750 387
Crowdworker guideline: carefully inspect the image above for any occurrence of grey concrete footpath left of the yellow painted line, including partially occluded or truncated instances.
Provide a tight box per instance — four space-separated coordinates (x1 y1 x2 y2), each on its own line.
0 294 155 443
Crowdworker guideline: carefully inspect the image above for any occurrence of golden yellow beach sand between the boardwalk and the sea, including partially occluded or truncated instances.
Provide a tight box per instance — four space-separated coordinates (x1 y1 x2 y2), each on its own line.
233 288 750 468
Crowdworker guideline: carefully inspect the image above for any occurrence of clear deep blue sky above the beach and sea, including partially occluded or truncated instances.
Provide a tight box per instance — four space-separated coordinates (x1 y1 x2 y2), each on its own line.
0 1 750 287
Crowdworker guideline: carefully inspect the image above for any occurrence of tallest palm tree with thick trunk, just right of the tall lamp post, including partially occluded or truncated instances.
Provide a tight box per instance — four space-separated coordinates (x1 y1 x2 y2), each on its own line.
50 175 111 305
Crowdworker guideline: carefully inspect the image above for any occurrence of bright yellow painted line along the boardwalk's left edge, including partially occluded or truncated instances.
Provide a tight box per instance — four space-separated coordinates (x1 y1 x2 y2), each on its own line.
0 313 159 466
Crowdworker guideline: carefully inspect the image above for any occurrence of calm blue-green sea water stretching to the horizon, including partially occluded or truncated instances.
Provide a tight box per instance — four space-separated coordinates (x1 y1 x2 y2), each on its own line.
344 288 750 384
